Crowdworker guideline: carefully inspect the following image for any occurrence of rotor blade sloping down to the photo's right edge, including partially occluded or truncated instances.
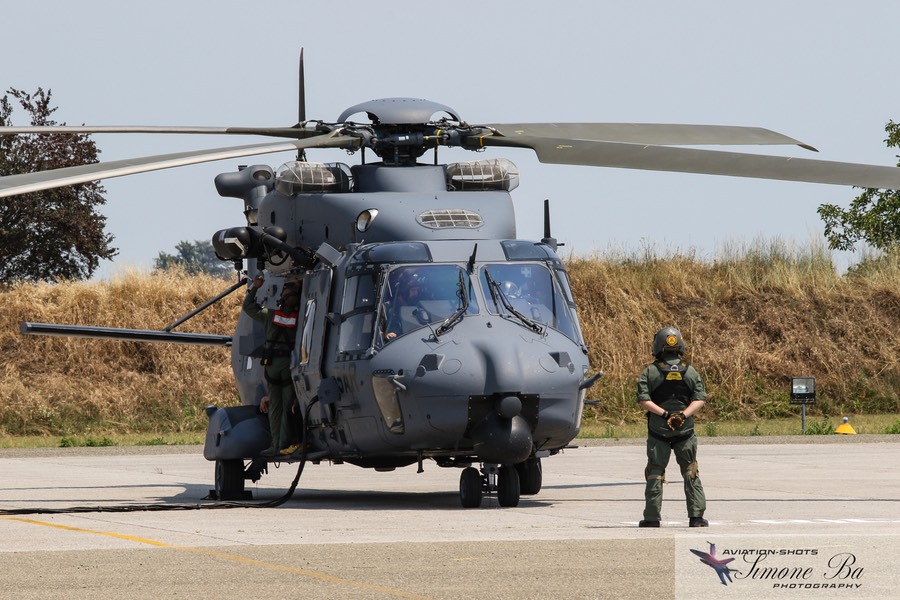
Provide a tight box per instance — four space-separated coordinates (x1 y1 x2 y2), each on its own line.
468 136 900 190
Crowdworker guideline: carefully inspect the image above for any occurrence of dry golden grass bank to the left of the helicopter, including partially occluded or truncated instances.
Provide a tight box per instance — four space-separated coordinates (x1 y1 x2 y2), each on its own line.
0 272 240 435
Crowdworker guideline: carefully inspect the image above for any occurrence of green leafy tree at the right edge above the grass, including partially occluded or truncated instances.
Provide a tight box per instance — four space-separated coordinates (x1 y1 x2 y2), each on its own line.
818 121 900 250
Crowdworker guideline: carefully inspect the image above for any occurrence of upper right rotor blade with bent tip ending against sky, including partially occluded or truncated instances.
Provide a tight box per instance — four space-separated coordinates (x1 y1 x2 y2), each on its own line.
488 123 818 152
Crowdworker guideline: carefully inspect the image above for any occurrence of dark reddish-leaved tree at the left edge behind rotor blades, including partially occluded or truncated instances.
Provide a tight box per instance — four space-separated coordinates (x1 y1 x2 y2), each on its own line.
0 88 117 283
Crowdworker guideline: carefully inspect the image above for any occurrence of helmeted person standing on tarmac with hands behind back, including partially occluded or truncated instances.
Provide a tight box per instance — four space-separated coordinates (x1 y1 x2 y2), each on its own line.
637 327 709 527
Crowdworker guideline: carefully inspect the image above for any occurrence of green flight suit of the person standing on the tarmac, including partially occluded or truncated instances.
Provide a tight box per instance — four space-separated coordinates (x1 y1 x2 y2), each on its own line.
637 354 706 521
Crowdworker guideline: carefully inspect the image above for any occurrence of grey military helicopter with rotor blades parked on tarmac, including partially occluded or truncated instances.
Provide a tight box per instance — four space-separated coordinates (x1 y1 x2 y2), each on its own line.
0 54 900 507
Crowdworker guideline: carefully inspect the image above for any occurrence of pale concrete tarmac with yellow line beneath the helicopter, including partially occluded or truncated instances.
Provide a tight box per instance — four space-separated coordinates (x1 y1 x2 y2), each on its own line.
0 435 900 600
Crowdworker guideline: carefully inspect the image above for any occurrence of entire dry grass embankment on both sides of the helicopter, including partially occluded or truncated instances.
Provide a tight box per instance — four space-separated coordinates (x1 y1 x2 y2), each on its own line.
0 243 900 438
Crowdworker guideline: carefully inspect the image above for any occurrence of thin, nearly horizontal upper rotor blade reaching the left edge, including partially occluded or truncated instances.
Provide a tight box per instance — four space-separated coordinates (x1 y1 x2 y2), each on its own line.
0 121 323 139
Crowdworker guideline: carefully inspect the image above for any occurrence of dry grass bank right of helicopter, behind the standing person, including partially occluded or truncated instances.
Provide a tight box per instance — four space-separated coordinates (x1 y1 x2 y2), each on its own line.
568 243 900 423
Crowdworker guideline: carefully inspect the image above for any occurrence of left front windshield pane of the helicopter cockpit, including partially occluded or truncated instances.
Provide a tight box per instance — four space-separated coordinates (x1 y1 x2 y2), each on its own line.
379 265 478 342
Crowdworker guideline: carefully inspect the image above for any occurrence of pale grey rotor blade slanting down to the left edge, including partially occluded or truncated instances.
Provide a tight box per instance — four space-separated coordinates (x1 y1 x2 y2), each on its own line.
0 134 359 198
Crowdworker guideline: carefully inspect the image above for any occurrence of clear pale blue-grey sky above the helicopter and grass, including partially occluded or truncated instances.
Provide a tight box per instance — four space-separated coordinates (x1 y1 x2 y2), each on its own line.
0 0 900 277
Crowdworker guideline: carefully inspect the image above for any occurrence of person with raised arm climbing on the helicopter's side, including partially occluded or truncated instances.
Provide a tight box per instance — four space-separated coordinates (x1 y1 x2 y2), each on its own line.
243 274 300 456
